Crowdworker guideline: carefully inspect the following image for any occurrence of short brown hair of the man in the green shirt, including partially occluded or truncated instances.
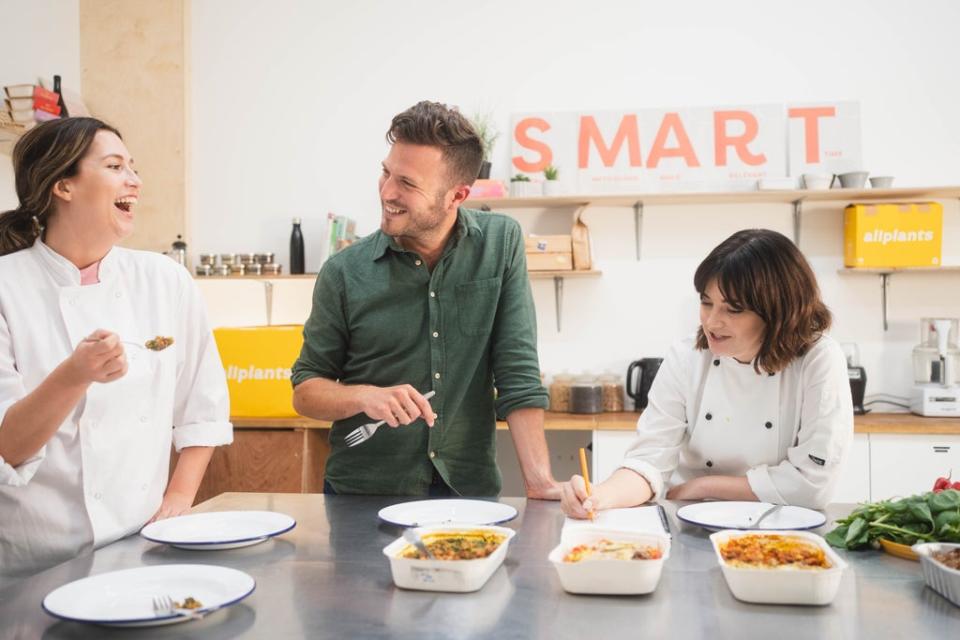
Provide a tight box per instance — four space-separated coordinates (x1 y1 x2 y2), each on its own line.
387 100 483 184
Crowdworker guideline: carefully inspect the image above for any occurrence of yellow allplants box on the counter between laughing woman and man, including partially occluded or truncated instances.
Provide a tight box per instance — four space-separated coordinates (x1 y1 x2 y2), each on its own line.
213 324 303 418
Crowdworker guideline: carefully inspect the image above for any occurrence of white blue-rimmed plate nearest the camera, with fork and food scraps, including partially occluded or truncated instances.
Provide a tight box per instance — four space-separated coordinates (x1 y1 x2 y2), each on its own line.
43 564 256 627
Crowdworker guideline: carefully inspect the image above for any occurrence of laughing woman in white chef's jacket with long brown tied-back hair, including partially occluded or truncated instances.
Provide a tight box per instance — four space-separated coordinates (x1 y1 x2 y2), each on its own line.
0 118 232 581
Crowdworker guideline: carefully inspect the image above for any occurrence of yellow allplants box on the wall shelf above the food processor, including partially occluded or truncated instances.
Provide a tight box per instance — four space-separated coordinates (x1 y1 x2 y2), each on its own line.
843 202 943 267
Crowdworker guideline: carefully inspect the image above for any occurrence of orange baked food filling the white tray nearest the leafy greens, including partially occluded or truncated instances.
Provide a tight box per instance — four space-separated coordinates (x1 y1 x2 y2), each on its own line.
720 534 833 569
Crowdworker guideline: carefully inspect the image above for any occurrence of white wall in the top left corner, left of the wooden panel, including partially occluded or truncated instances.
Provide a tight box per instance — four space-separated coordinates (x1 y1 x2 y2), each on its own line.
0 0 80 211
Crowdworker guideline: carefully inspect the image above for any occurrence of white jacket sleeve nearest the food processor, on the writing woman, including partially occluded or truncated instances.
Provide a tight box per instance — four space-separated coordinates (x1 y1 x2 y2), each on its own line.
747 341 853 509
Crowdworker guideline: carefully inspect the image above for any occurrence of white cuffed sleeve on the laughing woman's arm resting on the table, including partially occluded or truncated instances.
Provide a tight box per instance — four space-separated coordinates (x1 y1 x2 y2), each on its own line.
173 271 233 451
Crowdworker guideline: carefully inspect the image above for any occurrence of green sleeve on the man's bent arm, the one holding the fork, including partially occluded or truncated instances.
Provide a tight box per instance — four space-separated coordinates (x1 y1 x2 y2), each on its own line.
291 259 349 387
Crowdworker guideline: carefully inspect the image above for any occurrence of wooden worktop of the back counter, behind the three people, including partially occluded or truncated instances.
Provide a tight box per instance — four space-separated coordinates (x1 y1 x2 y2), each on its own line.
231 411 960 435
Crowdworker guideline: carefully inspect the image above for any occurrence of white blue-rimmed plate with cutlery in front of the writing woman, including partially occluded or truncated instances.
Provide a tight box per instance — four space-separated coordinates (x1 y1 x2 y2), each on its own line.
677 500 827 531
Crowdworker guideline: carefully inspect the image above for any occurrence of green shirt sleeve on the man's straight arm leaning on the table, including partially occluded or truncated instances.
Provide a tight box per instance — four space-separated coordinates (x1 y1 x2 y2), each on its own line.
491 223 550 419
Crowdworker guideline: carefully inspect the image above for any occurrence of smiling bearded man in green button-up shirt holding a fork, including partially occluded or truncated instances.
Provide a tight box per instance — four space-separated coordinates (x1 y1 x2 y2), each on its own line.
293 102 560 499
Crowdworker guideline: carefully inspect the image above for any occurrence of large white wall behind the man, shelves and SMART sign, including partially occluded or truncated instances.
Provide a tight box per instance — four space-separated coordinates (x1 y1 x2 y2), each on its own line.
191 0 960 394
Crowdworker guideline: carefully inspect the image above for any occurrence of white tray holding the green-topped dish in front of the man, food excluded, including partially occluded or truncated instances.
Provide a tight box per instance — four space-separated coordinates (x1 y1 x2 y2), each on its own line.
383 524 516 593
